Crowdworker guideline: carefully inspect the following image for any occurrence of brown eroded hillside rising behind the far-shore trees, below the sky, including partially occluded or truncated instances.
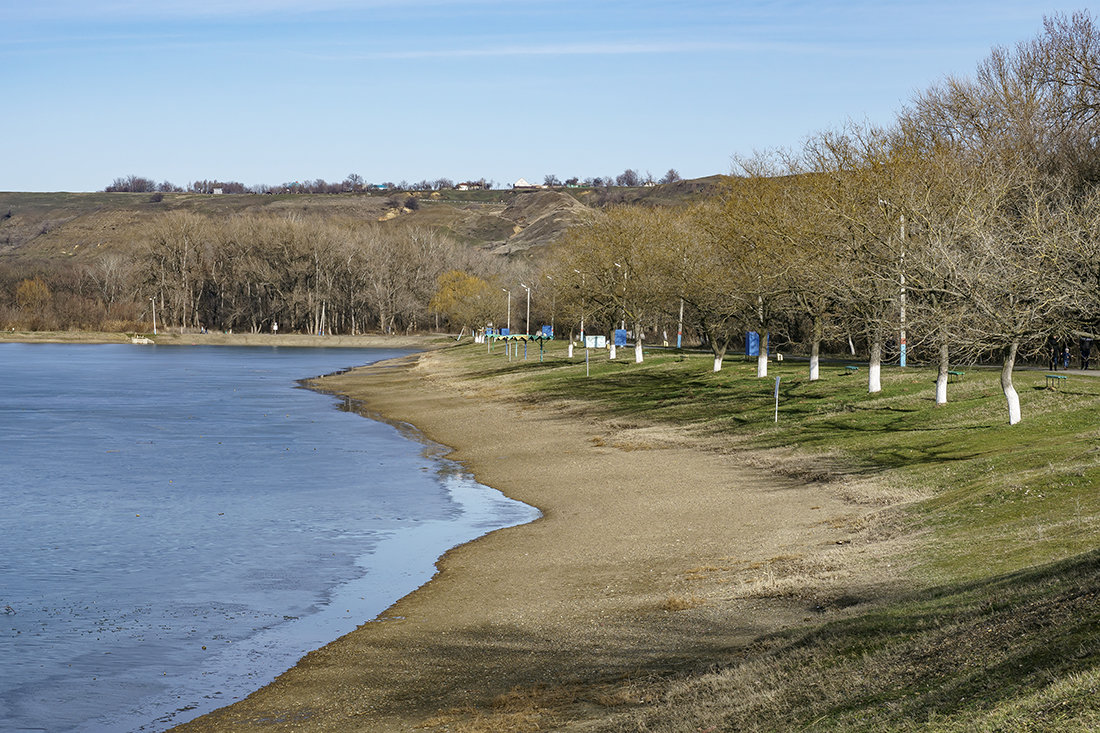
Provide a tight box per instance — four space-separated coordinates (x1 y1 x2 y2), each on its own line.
0 176 719 262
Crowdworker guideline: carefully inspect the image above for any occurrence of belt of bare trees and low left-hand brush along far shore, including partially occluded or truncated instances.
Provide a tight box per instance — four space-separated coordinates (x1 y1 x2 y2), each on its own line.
0 211 523 333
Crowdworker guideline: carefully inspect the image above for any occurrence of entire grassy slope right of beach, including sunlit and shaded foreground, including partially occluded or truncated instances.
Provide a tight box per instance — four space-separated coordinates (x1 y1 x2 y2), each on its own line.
446 344 1100 731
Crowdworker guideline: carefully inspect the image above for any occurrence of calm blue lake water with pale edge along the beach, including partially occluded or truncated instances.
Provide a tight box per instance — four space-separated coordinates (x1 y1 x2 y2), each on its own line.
0 343 536 731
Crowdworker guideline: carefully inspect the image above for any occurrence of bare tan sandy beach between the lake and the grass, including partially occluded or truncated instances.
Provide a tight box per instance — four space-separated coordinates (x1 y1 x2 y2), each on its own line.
167 351 881 732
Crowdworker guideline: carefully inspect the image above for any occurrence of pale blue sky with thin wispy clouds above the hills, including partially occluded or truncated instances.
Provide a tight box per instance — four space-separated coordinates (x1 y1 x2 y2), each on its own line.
0 0 1085 192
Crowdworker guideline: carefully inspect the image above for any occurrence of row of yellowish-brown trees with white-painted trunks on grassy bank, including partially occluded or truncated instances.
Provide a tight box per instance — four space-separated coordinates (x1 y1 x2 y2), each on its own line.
543 13 1100 423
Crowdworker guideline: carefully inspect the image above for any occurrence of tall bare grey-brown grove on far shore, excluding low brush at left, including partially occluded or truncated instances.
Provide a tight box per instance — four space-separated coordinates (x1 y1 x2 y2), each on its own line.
145 214 519 333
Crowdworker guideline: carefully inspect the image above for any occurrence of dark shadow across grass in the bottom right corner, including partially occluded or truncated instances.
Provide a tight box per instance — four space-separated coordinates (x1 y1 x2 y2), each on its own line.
624 551 1100 731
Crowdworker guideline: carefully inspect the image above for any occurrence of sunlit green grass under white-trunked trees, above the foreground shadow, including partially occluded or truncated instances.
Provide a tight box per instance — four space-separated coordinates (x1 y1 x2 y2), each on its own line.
463 342 1100 581
